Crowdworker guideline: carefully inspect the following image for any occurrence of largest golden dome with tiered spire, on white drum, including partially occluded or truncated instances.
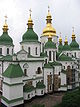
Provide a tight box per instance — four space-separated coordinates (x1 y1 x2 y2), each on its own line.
42 7 56 36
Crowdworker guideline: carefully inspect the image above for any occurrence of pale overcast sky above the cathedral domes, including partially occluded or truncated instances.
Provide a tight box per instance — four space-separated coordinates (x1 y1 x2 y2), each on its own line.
0 0 80 52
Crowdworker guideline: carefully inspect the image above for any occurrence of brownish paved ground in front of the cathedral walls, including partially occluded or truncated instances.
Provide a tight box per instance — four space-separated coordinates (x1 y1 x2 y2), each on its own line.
25 93 64 107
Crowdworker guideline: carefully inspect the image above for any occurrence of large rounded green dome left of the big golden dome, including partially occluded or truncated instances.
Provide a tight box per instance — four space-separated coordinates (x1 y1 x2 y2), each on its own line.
22 28 38 42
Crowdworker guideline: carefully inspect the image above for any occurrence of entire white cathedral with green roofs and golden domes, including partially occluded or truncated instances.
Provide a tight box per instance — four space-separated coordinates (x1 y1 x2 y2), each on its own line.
0 9 80 107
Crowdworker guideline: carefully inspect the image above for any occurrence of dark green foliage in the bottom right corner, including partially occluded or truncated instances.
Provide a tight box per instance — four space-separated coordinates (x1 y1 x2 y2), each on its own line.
62 90 80 107
